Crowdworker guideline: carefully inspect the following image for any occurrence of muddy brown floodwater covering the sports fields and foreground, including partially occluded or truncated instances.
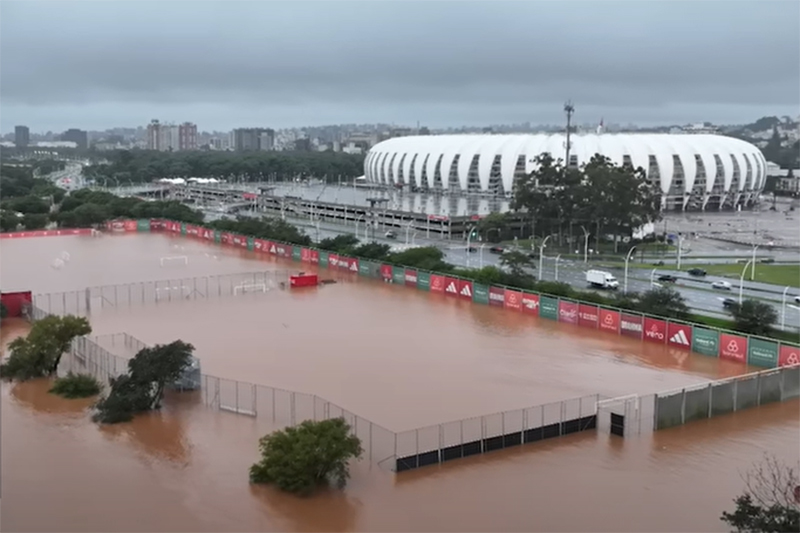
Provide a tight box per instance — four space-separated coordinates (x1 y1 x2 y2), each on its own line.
0 235 800 531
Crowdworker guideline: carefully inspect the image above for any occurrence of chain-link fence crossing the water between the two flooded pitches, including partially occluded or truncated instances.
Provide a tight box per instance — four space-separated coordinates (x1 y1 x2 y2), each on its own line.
33 270 289 316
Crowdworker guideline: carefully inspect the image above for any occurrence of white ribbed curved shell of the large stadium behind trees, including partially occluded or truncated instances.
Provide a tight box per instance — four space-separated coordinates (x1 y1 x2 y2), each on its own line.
364 133 767 210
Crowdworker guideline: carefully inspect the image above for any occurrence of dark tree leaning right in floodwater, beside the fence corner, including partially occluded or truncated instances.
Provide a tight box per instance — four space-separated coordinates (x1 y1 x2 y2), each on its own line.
94 341 194 424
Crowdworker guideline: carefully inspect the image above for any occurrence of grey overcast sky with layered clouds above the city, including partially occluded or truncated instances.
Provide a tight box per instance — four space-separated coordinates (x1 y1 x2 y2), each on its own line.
0 0 800 132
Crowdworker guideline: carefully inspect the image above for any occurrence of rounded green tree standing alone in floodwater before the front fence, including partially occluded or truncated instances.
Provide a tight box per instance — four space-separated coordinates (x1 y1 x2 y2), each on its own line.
250 418 364 495
